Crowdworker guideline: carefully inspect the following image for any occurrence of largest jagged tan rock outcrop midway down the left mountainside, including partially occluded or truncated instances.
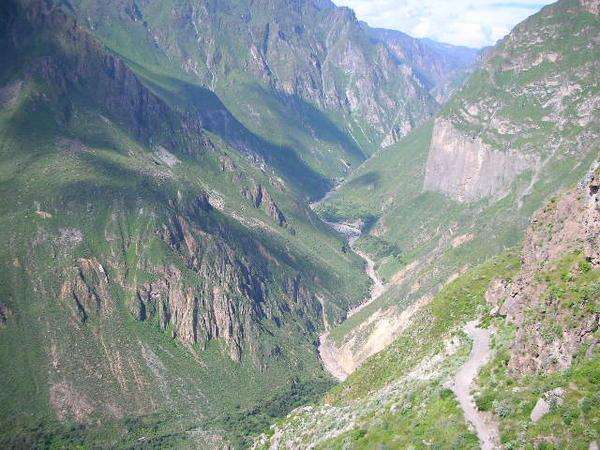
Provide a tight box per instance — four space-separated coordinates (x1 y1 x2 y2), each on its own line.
151 211 266 360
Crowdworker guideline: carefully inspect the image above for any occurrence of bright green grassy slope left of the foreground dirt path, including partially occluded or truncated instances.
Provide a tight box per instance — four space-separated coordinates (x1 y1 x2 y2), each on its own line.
255 254 519 448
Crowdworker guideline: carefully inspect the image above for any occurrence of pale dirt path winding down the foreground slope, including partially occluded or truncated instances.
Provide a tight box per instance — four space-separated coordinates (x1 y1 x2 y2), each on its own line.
450 321 501 450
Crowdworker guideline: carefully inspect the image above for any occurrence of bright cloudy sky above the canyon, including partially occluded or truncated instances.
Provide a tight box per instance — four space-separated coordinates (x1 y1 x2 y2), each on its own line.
334 0 553 48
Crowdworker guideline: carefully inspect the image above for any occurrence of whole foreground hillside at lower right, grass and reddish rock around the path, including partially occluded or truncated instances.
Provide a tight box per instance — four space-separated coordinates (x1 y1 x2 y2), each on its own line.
256 165 600 449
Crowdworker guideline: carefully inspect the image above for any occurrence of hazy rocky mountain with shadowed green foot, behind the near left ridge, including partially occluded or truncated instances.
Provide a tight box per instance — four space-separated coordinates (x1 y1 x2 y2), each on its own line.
57 0 474 188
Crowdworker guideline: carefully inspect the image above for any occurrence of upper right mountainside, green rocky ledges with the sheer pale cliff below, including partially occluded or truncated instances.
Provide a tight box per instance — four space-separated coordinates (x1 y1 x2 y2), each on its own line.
424 1 600 202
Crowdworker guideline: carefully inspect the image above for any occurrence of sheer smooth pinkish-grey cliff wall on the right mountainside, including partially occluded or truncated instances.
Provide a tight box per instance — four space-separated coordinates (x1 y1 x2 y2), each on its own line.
423 118 536 203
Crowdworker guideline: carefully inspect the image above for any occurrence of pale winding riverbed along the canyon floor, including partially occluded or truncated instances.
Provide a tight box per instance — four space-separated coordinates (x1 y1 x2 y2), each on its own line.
319 218 386 381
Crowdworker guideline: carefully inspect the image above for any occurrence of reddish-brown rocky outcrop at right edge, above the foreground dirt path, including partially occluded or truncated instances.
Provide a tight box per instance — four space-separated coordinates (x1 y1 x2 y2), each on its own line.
486 168 600 375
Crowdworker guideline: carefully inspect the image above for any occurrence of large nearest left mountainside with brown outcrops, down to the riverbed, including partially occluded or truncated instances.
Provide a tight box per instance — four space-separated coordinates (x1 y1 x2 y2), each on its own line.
0 0 367 447
